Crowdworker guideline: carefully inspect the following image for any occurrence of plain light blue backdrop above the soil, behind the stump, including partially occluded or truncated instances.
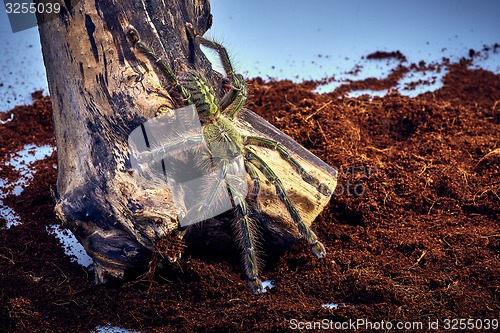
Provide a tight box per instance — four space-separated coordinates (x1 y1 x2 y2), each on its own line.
0 0 500 112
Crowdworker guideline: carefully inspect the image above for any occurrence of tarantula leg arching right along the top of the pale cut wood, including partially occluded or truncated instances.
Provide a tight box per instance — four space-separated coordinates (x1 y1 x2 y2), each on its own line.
244 136 332 195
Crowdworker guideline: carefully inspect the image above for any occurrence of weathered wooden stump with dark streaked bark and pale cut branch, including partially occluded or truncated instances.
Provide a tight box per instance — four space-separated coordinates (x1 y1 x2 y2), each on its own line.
35 0 336 282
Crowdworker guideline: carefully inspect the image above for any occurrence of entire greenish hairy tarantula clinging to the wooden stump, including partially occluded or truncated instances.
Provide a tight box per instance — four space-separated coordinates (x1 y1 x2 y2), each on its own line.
127 23 332 294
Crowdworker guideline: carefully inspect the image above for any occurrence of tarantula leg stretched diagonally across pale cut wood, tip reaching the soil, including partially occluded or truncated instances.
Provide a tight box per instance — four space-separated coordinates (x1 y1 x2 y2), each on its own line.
245 150 326 258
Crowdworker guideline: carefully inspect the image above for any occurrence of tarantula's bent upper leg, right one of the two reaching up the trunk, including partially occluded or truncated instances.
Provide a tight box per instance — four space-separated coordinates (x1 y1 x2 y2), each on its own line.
186 23 248 119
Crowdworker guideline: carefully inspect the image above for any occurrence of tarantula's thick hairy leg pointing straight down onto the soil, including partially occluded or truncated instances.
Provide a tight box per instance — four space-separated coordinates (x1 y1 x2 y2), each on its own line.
233 192 263 295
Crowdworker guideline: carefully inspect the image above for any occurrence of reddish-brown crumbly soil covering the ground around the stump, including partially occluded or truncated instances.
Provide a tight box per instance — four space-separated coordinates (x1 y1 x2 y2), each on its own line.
0 53 500 332
